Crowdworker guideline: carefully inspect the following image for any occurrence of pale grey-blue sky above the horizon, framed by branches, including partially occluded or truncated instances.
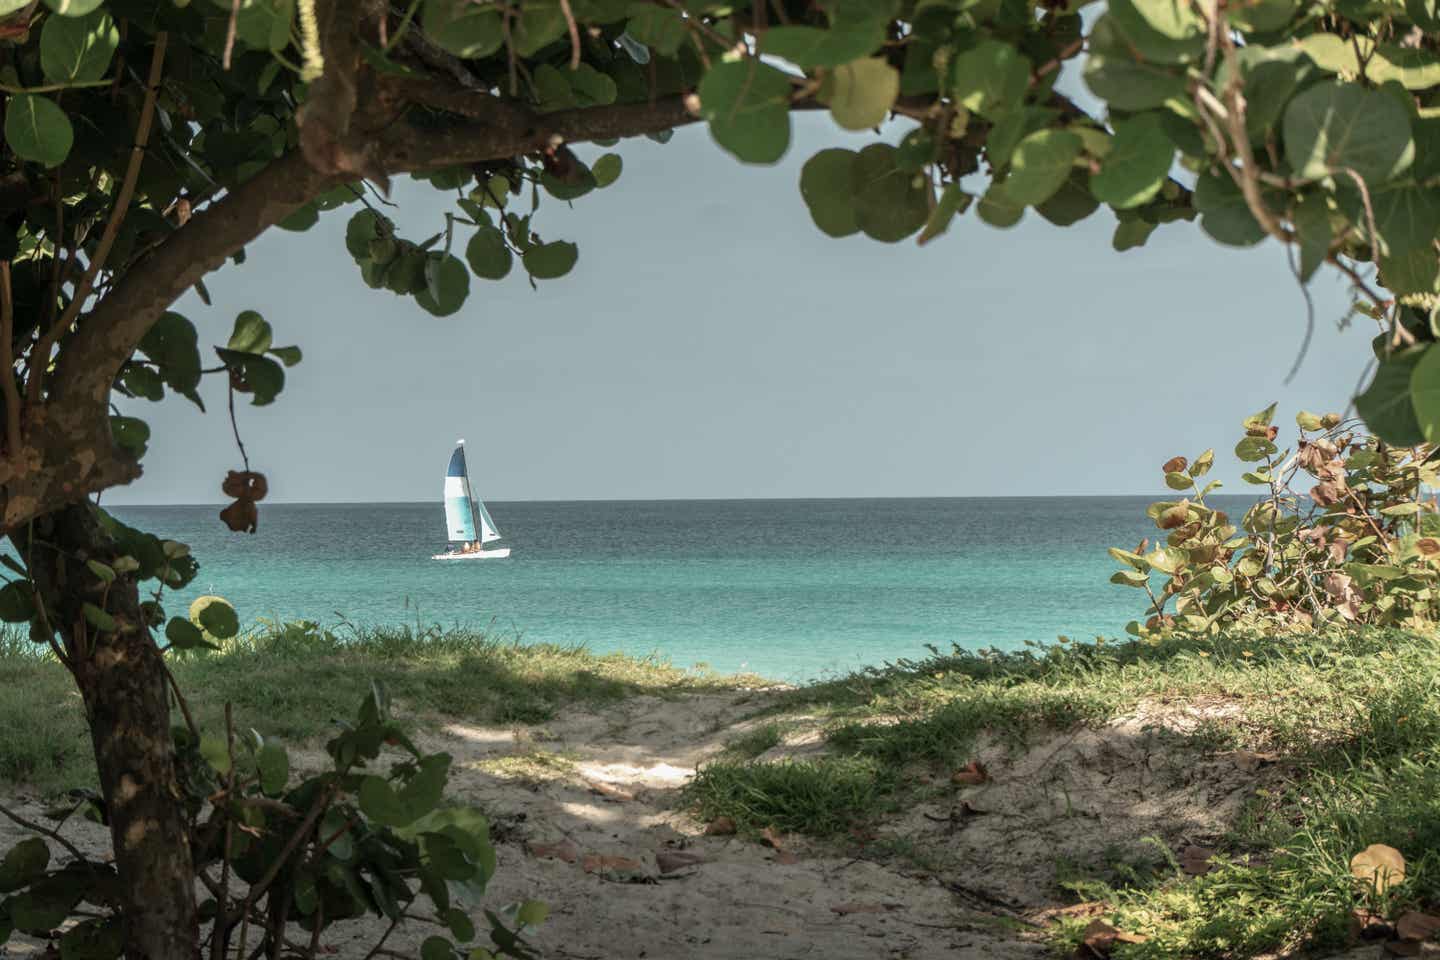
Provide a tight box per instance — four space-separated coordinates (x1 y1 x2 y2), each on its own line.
105 115 1374 504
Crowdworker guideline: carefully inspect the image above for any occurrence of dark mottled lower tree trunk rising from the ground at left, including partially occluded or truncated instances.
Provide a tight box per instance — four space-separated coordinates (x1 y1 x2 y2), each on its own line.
14 502 199 960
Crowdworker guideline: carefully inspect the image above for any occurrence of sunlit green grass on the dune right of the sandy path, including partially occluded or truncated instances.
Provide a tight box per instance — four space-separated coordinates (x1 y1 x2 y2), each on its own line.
673 629 1440 960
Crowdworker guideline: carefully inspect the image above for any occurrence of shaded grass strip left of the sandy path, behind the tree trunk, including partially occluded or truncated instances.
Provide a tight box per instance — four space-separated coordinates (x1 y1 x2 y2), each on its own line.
0 623 757 793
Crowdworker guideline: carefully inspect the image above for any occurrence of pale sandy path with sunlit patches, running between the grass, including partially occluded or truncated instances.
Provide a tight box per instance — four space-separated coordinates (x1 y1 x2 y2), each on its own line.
0 692 1273 960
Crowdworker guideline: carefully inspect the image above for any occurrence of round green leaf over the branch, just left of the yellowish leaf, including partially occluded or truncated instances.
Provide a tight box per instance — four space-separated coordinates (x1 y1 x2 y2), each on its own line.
698 58 791 163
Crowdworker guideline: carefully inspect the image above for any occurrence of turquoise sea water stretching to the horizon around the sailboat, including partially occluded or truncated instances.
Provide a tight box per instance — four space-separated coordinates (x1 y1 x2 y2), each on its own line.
114 497 1241 681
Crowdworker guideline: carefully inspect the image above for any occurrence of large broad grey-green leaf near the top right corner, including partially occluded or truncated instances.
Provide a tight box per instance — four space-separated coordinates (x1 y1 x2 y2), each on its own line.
1282 82 1416 187
